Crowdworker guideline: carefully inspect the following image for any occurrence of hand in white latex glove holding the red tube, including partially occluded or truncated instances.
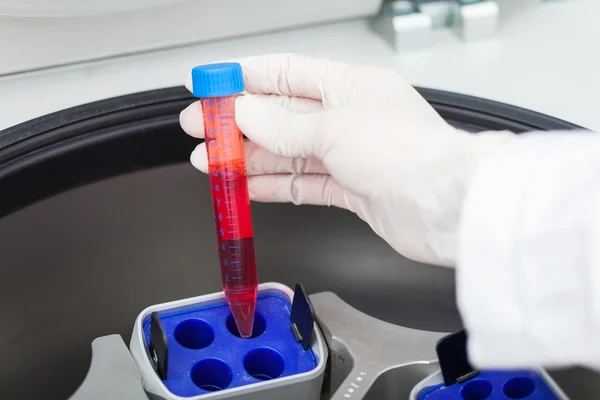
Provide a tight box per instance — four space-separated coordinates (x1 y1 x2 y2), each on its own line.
180 54 512 266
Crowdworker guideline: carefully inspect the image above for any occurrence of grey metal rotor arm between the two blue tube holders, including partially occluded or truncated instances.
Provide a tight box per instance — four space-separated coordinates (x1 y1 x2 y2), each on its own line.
311 292 446 400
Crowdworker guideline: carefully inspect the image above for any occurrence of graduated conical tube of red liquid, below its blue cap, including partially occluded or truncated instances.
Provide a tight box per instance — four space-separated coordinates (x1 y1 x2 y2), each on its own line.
200 95 258 338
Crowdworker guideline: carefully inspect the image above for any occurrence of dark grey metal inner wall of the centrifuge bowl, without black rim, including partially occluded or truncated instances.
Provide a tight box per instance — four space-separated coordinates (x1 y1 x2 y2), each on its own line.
0 161 600 399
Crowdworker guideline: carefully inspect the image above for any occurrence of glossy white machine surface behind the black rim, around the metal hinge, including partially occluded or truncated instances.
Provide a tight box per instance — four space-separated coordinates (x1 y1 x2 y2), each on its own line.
0 0 600 130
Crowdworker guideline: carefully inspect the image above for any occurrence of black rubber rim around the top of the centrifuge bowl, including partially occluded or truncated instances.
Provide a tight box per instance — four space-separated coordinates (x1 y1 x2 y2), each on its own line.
0 87 582 218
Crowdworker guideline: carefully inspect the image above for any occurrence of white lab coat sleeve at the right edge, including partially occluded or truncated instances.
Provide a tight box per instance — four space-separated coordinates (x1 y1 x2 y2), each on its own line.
456 132 600 369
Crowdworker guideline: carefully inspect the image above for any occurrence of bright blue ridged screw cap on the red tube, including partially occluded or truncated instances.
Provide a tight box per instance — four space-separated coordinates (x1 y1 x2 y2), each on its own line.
192 63 244 98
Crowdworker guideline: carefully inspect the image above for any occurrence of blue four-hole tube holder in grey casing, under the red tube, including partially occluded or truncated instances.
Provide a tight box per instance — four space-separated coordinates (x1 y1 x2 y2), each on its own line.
130 283 327 400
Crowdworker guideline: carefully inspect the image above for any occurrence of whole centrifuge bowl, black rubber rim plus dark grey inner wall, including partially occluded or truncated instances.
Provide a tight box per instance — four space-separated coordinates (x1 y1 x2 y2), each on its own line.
0 88 600 399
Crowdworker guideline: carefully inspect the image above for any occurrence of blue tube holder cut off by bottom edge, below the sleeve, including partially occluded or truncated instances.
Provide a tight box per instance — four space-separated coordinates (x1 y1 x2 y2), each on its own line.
409 370 568 400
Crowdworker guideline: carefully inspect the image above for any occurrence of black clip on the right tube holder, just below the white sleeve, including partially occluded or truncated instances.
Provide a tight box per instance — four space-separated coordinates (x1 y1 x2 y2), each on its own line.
435 330 479 386
